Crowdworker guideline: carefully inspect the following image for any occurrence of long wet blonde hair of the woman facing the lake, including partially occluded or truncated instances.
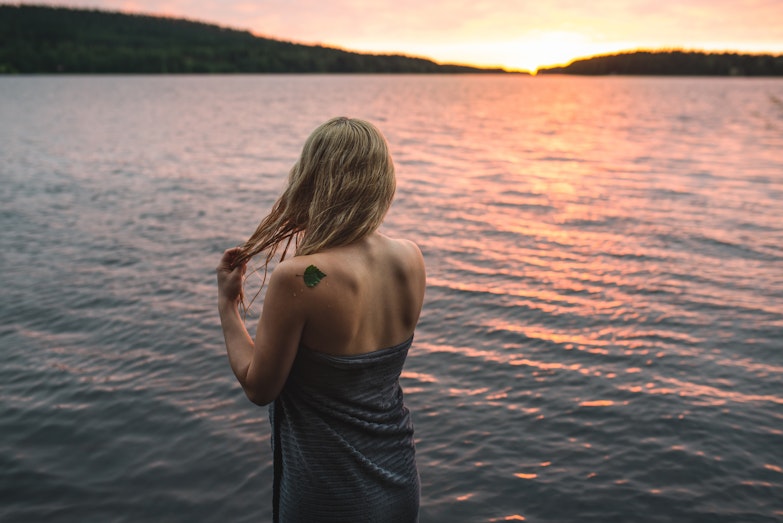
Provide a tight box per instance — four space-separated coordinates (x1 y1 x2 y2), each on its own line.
231 117 396 272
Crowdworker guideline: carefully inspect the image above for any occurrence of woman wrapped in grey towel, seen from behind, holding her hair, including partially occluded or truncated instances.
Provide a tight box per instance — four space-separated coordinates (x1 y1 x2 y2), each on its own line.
217 118 425 523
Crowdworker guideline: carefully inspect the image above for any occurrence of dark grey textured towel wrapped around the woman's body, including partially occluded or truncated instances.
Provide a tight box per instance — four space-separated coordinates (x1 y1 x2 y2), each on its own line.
270 337 419 523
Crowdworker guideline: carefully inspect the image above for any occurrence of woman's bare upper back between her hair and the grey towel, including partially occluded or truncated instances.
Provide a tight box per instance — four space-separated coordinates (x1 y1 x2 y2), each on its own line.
275 233 425 355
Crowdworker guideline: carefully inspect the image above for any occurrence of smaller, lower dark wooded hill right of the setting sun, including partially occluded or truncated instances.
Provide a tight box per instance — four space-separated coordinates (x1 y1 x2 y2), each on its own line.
538 51 783 76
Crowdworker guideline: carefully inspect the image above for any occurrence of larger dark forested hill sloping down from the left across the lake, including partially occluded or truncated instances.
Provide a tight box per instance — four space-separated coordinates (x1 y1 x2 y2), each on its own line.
0 5 505 73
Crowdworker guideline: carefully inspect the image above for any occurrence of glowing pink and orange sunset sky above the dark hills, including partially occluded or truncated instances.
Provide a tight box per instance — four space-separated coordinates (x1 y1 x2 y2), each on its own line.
23 0 783 71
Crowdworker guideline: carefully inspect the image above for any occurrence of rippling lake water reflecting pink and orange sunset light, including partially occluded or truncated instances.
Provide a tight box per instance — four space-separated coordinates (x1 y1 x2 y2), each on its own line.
0 75 783 523
